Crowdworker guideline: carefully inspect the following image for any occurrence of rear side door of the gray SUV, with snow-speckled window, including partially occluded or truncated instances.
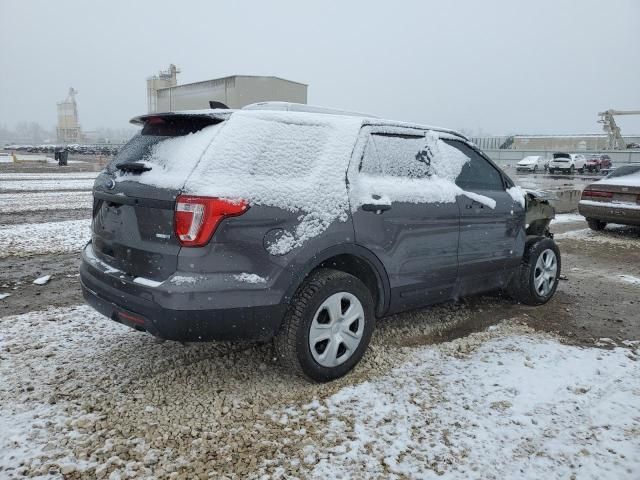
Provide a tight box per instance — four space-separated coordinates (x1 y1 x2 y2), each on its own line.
350 129 460 313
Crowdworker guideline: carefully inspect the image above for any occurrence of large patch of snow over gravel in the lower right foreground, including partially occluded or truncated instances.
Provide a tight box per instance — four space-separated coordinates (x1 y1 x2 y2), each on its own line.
268 333 640 479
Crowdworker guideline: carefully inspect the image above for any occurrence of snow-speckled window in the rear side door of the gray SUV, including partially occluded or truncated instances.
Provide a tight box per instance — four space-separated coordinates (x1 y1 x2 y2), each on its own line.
360 134 428 178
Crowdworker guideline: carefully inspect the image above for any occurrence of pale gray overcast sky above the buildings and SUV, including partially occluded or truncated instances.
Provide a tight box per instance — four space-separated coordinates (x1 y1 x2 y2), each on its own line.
0 0 640 134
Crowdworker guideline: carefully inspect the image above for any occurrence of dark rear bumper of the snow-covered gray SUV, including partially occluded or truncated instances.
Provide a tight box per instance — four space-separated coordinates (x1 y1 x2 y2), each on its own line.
80 247 287 342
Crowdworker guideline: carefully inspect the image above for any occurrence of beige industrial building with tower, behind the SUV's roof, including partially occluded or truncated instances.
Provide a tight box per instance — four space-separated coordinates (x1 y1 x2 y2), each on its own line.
147 65 307 113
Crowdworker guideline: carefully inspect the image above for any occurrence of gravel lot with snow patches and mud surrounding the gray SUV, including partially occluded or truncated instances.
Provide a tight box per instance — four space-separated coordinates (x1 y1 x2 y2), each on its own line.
0 163 640 478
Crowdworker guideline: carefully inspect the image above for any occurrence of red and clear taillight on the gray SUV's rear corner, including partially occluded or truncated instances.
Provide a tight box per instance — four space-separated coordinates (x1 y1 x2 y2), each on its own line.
174 195 249 247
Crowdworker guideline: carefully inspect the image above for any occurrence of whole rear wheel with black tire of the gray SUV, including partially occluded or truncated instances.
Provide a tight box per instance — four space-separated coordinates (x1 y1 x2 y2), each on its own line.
274 269 375 382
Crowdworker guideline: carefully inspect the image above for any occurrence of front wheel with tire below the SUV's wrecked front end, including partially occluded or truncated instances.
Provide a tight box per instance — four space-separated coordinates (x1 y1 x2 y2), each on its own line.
507 237 561 305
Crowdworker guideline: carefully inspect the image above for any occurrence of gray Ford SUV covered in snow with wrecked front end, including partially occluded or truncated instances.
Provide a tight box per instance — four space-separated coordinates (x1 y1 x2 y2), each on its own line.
80 103 560 381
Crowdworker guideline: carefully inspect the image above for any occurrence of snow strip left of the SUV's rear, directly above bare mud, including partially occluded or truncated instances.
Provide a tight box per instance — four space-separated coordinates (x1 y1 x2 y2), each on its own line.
0 219 91 258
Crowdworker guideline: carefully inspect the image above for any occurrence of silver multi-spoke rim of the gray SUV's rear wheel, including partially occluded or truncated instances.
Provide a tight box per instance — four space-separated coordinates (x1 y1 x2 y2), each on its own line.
309 292 365 368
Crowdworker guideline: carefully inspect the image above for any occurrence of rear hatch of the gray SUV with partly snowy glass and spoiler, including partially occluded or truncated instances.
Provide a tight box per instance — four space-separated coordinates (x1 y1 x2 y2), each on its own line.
92 114 224 281
